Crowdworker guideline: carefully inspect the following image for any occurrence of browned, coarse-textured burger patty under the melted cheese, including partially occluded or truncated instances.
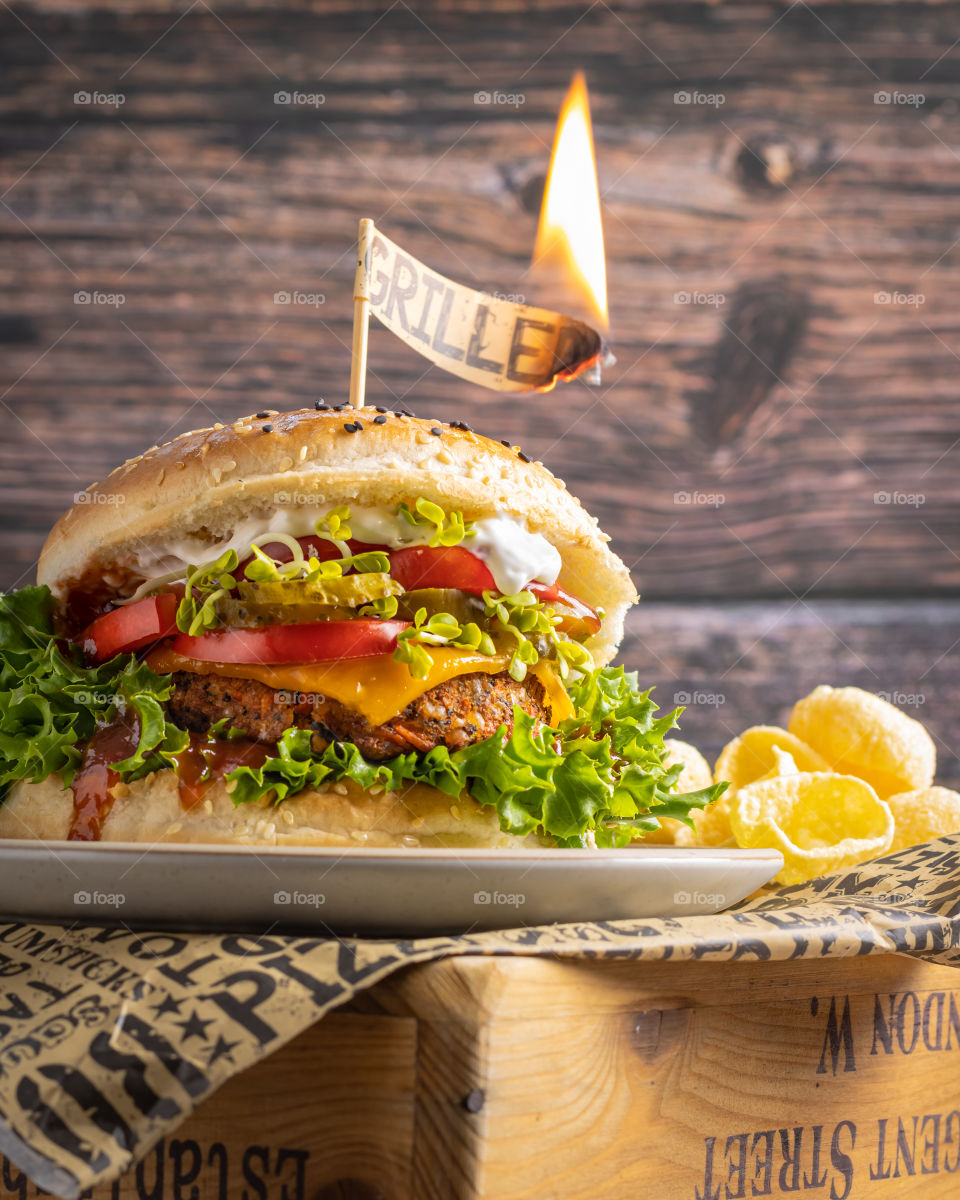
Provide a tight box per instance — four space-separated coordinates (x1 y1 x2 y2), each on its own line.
167 671 550 761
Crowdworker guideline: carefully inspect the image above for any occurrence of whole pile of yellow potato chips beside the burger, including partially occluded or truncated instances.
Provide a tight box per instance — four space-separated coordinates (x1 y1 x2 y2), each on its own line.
662 686 960 883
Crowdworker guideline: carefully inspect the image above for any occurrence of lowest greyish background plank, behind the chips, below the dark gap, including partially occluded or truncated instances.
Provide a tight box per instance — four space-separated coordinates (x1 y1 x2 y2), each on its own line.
618 600 960 787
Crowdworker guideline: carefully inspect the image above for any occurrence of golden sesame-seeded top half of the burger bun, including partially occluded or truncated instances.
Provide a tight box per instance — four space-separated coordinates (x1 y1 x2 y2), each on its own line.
37 408 636 662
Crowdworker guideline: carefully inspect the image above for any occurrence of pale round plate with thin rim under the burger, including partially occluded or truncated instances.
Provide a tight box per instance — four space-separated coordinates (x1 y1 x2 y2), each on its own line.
0 840 782 937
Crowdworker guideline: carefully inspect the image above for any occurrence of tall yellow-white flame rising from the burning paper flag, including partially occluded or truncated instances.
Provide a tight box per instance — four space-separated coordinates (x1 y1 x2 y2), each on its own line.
533 71 608 329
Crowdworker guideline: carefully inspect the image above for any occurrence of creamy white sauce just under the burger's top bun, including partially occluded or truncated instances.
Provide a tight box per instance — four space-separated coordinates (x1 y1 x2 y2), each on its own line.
129 504 562 594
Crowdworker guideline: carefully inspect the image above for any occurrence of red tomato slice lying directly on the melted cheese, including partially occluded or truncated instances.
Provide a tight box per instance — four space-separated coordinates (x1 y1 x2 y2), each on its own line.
172 617 410 665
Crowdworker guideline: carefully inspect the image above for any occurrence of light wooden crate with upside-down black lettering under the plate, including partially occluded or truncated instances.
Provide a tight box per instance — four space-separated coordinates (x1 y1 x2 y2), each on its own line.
0 956 960 1200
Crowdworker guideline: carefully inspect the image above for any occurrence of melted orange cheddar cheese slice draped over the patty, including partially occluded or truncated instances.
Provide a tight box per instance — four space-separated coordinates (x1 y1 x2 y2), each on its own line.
146 647 574 725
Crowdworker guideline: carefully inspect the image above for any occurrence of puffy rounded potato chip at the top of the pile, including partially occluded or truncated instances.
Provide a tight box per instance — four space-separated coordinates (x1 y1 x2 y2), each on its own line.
790 686 936 799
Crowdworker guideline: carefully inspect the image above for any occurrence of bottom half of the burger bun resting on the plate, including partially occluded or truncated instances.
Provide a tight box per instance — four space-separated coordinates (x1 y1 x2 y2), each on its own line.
0 770 552 850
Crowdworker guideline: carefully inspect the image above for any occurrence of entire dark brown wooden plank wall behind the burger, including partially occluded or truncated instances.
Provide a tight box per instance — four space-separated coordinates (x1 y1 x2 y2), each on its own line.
0 0 960 778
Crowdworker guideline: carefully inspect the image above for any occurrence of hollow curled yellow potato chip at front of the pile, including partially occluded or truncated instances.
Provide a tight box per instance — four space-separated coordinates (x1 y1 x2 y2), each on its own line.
730 772 894 883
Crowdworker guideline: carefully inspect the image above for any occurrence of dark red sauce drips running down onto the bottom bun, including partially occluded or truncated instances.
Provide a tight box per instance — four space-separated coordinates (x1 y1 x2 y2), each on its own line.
67 712 272 841
